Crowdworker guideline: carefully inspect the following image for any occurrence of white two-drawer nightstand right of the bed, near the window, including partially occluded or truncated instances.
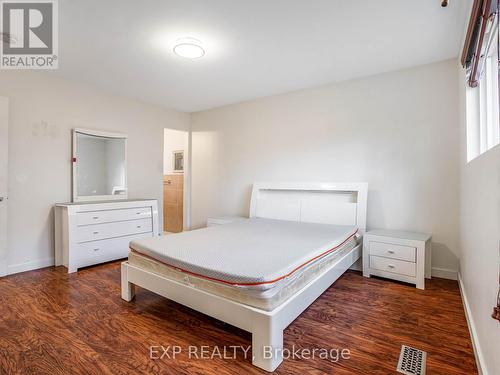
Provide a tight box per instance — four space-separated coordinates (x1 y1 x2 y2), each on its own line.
363 229 432 289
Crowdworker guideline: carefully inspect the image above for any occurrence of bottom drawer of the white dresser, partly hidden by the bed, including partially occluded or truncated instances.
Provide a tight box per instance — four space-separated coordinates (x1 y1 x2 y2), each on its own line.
73 233 153 262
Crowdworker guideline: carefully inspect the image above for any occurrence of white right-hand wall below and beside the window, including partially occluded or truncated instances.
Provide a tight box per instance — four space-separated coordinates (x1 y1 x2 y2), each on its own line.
459 63 500 374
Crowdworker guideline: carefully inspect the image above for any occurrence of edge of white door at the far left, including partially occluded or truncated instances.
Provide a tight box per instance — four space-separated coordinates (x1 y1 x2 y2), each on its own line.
0 96 9 276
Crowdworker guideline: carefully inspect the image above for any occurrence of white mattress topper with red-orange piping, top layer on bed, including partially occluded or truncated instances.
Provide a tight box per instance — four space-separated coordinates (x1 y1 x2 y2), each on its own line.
130 218 357 289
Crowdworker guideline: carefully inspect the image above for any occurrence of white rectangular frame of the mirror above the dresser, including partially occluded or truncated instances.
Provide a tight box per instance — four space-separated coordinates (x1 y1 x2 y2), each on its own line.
71 128 128 202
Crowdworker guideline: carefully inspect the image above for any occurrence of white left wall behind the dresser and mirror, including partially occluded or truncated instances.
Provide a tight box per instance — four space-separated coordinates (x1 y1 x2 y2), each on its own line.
0 71 190 272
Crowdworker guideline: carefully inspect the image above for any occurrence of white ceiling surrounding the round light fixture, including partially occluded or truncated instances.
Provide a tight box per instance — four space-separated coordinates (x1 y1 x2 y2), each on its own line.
54 0 469 112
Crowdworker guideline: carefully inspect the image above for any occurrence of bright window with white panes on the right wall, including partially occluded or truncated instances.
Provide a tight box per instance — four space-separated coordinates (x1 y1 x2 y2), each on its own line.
466 11 500 162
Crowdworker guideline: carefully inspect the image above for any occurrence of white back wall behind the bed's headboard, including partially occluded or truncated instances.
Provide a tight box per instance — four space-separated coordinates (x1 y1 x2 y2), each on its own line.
191 60 459 276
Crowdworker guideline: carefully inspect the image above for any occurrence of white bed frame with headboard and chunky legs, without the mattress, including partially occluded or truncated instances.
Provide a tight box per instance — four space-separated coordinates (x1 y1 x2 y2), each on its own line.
121 183 368 372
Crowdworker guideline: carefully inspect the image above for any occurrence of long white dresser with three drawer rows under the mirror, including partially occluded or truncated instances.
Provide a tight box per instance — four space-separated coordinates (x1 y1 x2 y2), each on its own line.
55 199 158 273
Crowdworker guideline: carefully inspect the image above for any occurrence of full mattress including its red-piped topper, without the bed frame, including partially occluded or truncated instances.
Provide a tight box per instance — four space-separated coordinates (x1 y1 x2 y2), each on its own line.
129 219 358 310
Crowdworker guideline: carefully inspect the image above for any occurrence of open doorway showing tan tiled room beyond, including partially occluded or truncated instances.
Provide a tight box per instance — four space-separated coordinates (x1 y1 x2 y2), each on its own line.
163 129 189 234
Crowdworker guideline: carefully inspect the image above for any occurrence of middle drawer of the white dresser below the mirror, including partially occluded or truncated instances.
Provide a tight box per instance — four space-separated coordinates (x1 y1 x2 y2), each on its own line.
76 219 153 242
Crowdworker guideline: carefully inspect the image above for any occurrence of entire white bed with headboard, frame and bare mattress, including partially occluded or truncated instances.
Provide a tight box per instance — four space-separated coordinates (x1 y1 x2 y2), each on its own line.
121 183 368 371
